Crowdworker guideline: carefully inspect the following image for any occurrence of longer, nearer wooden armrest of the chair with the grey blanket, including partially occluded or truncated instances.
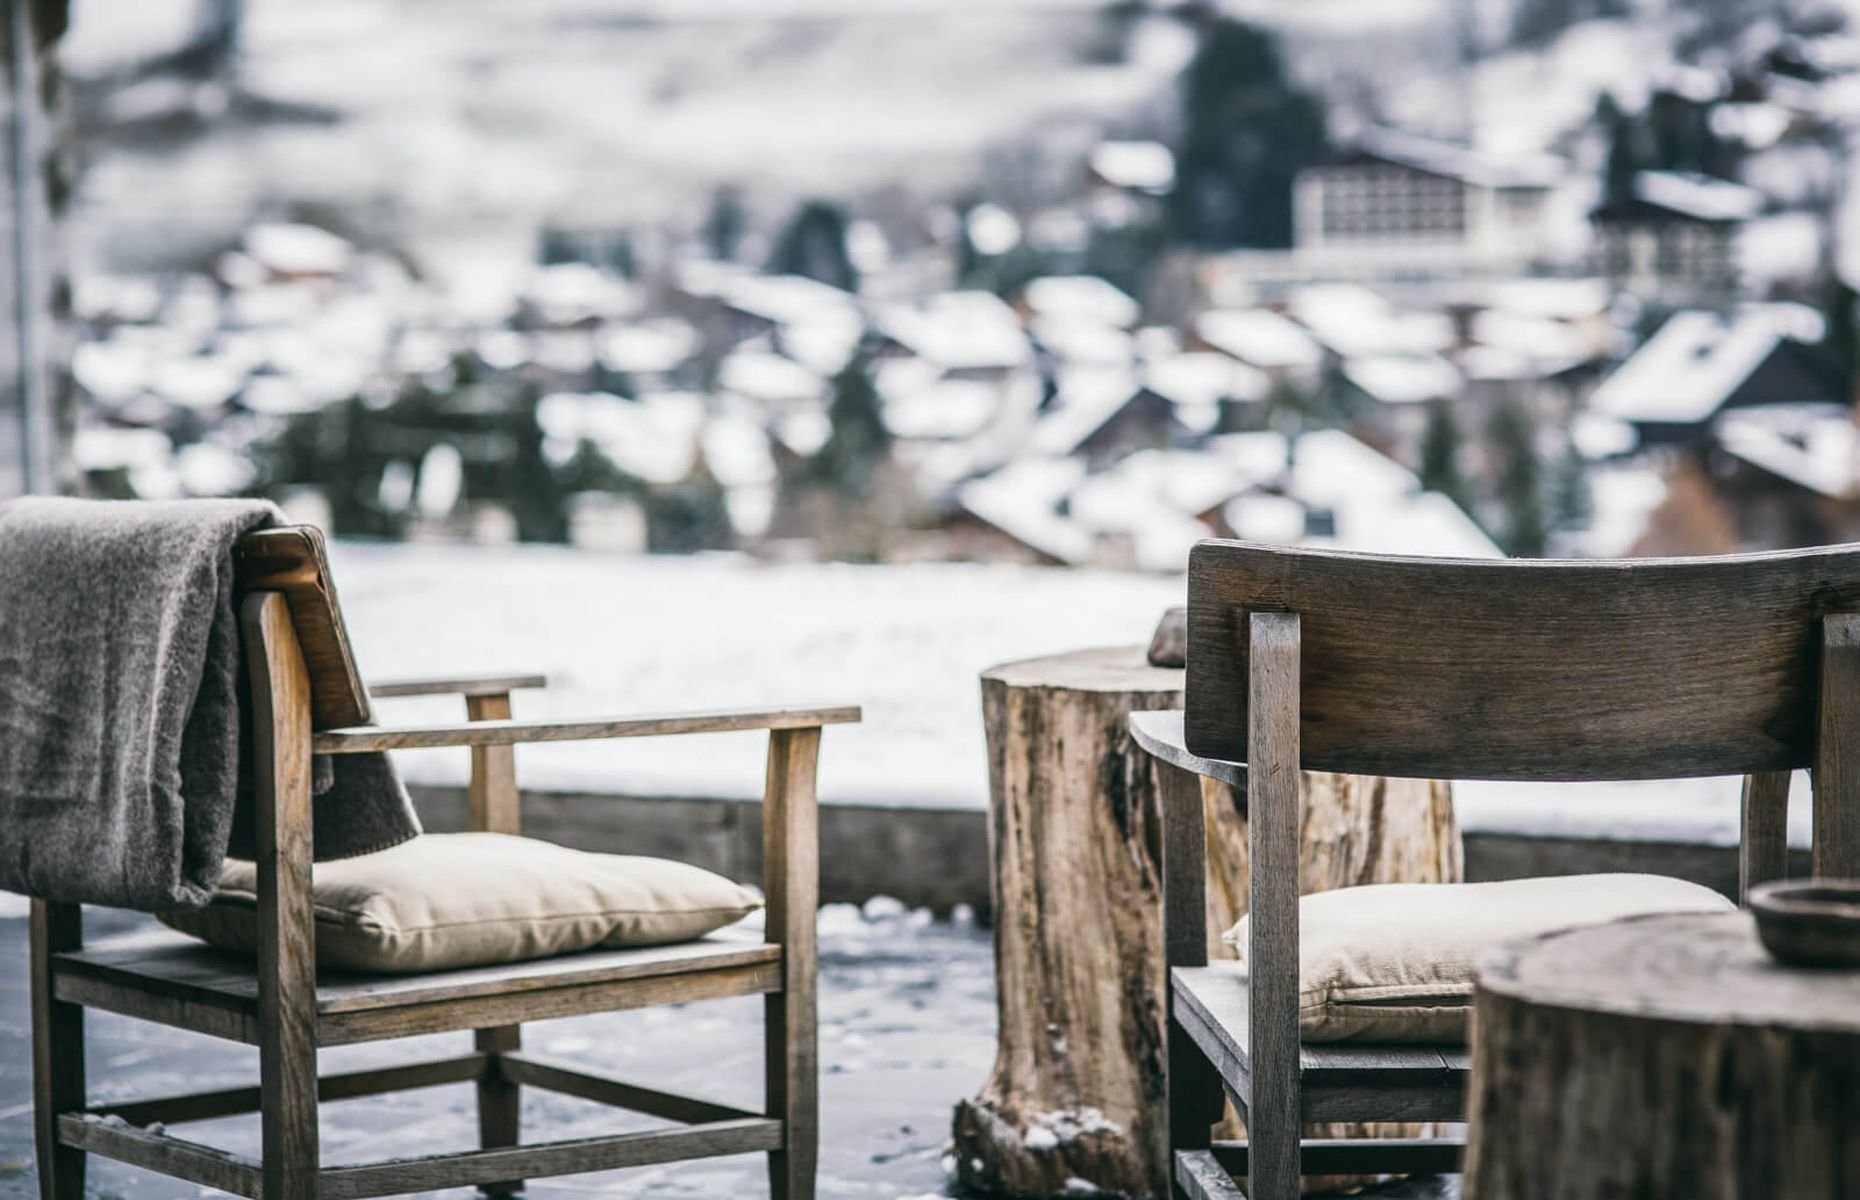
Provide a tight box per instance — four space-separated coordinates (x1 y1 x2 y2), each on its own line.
311 705 859 753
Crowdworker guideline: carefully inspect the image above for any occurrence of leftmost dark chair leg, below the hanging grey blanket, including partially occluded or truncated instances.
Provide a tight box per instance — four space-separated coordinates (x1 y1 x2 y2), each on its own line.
30 900 86 1200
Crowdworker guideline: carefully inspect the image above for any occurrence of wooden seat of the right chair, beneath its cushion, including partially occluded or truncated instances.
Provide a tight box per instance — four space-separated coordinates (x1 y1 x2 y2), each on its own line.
1170 962 1471 1122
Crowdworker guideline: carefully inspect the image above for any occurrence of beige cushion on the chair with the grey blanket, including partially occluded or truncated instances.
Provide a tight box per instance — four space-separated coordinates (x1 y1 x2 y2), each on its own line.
162 833 763 973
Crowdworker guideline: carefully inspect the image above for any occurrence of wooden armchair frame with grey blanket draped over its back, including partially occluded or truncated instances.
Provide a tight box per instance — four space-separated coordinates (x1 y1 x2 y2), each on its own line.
32 528 859 1200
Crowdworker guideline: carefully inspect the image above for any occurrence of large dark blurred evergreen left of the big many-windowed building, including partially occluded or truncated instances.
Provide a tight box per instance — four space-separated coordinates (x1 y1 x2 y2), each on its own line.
1170 17 1326 247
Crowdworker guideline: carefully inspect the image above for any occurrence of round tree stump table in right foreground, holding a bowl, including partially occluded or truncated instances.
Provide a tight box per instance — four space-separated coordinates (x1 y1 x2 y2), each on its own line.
1466 913 1860 1200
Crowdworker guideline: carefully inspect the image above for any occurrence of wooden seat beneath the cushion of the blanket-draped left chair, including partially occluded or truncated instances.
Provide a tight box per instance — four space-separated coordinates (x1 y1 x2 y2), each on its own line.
52 930 781 1046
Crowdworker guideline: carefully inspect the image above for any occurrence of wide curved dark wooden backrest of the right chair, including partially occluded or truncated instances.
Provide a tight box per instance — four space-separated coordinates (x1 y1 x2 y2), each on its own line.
1185 541 1860 780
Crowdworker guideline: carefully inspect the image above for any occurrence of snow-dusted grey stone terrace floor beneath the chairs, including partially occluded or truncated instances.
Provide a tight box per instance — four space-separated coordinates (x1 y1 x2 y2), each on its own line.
0 900 1455 1200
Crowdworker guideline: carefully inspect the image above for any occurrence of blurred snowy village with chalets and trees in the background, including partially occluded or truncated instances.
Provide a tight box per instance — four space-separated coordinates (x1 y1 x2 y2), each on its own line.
43 0 1860 573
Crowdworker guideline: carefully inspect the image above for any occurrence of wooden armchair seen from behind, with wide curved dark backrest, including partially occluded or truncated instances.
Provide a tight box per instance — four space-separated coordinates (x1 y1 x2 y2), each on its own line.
1131 541 1860 1200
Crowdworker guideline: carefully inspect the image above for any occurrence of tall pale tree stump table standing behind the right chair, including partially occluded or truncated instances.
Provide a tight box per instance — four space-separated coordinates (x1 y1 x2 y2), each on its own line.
954 646 1460 1196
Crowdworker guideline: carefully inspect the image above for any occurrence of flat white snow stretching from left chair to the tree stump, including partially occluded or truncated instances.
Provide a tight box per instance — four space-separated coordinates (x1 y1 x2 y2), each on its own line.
333 543 1183 807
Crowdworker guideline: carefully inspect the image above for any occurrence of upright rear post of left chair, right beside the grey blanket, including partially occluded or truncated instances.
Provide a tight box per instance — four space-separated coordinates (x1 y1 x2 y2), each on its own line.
240 592 318 1200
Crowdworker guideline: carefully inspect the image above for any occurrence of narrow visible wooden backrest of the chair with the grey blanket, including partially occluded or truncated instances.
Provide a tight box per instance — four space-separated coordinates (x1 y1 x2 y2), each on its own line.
234 525 372 729
